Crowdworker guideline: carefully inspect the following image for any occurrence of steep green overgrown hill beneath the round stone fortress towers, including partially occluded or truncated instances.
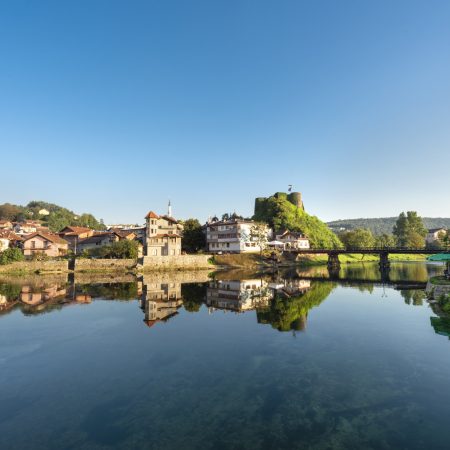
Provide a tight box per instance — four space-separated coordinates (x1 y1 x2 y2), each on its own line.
253 192 342 248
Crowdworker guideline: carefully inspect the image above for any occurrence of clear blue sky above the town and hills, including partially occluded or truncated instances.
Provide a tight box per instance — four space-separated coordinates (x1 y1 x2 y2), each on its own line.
0 0 450 223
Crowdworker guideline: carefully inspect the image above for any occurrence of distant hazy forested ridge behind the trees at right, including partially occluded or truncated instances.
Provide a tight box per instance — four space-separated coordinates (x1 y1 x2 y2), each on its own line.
327 217 450 236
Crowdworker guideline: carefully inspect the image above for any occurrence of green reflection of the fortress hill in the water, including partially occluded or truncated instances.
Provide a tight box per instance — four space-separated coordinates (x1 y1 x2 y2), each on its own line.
257 282 335 331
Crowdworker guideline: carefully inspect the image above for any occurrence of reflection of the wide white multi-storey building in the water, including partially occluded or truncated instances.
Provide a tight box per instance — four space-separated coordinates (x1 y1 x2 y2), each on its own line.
206 278 273 312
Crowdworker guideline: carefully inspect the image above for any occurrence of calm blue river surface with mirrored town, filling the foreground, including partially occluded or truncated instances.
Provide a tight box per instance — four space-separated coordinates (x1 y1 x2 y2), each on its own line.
0 264 450 450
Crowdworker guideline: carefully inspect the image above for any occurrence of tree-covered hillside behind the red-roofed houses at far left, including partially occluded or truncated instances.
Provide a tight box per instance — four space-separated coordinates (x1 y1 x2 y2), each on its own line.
0 201 106 232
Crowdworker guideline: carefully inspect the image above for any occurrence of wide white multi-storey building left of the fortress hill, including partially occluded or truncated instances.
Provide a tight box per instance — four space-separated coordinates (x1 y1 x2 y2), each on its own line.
206 218 272 253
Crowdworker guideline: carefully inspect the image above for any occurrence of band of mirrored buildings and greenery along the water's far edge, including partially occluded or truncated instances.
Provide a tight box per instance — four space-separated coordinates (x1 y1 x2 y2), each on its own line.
0 263 447 334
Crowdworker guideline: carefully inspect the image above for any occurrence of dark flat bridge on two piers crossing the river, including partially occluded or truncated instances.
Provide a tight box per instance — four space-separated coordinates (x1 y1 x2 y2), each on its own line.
286 247 442 270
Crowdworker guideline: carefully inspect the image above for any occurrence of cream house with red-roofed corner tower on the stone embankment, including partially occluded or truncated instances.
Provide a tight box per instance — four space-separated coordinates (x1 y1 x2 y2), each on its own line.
144 211 183 256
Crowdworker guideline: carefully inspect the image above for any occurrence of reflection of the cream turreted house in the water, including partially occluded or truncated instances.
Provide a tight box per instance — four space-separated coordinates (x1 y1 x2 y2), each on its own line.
141 282 183 327
